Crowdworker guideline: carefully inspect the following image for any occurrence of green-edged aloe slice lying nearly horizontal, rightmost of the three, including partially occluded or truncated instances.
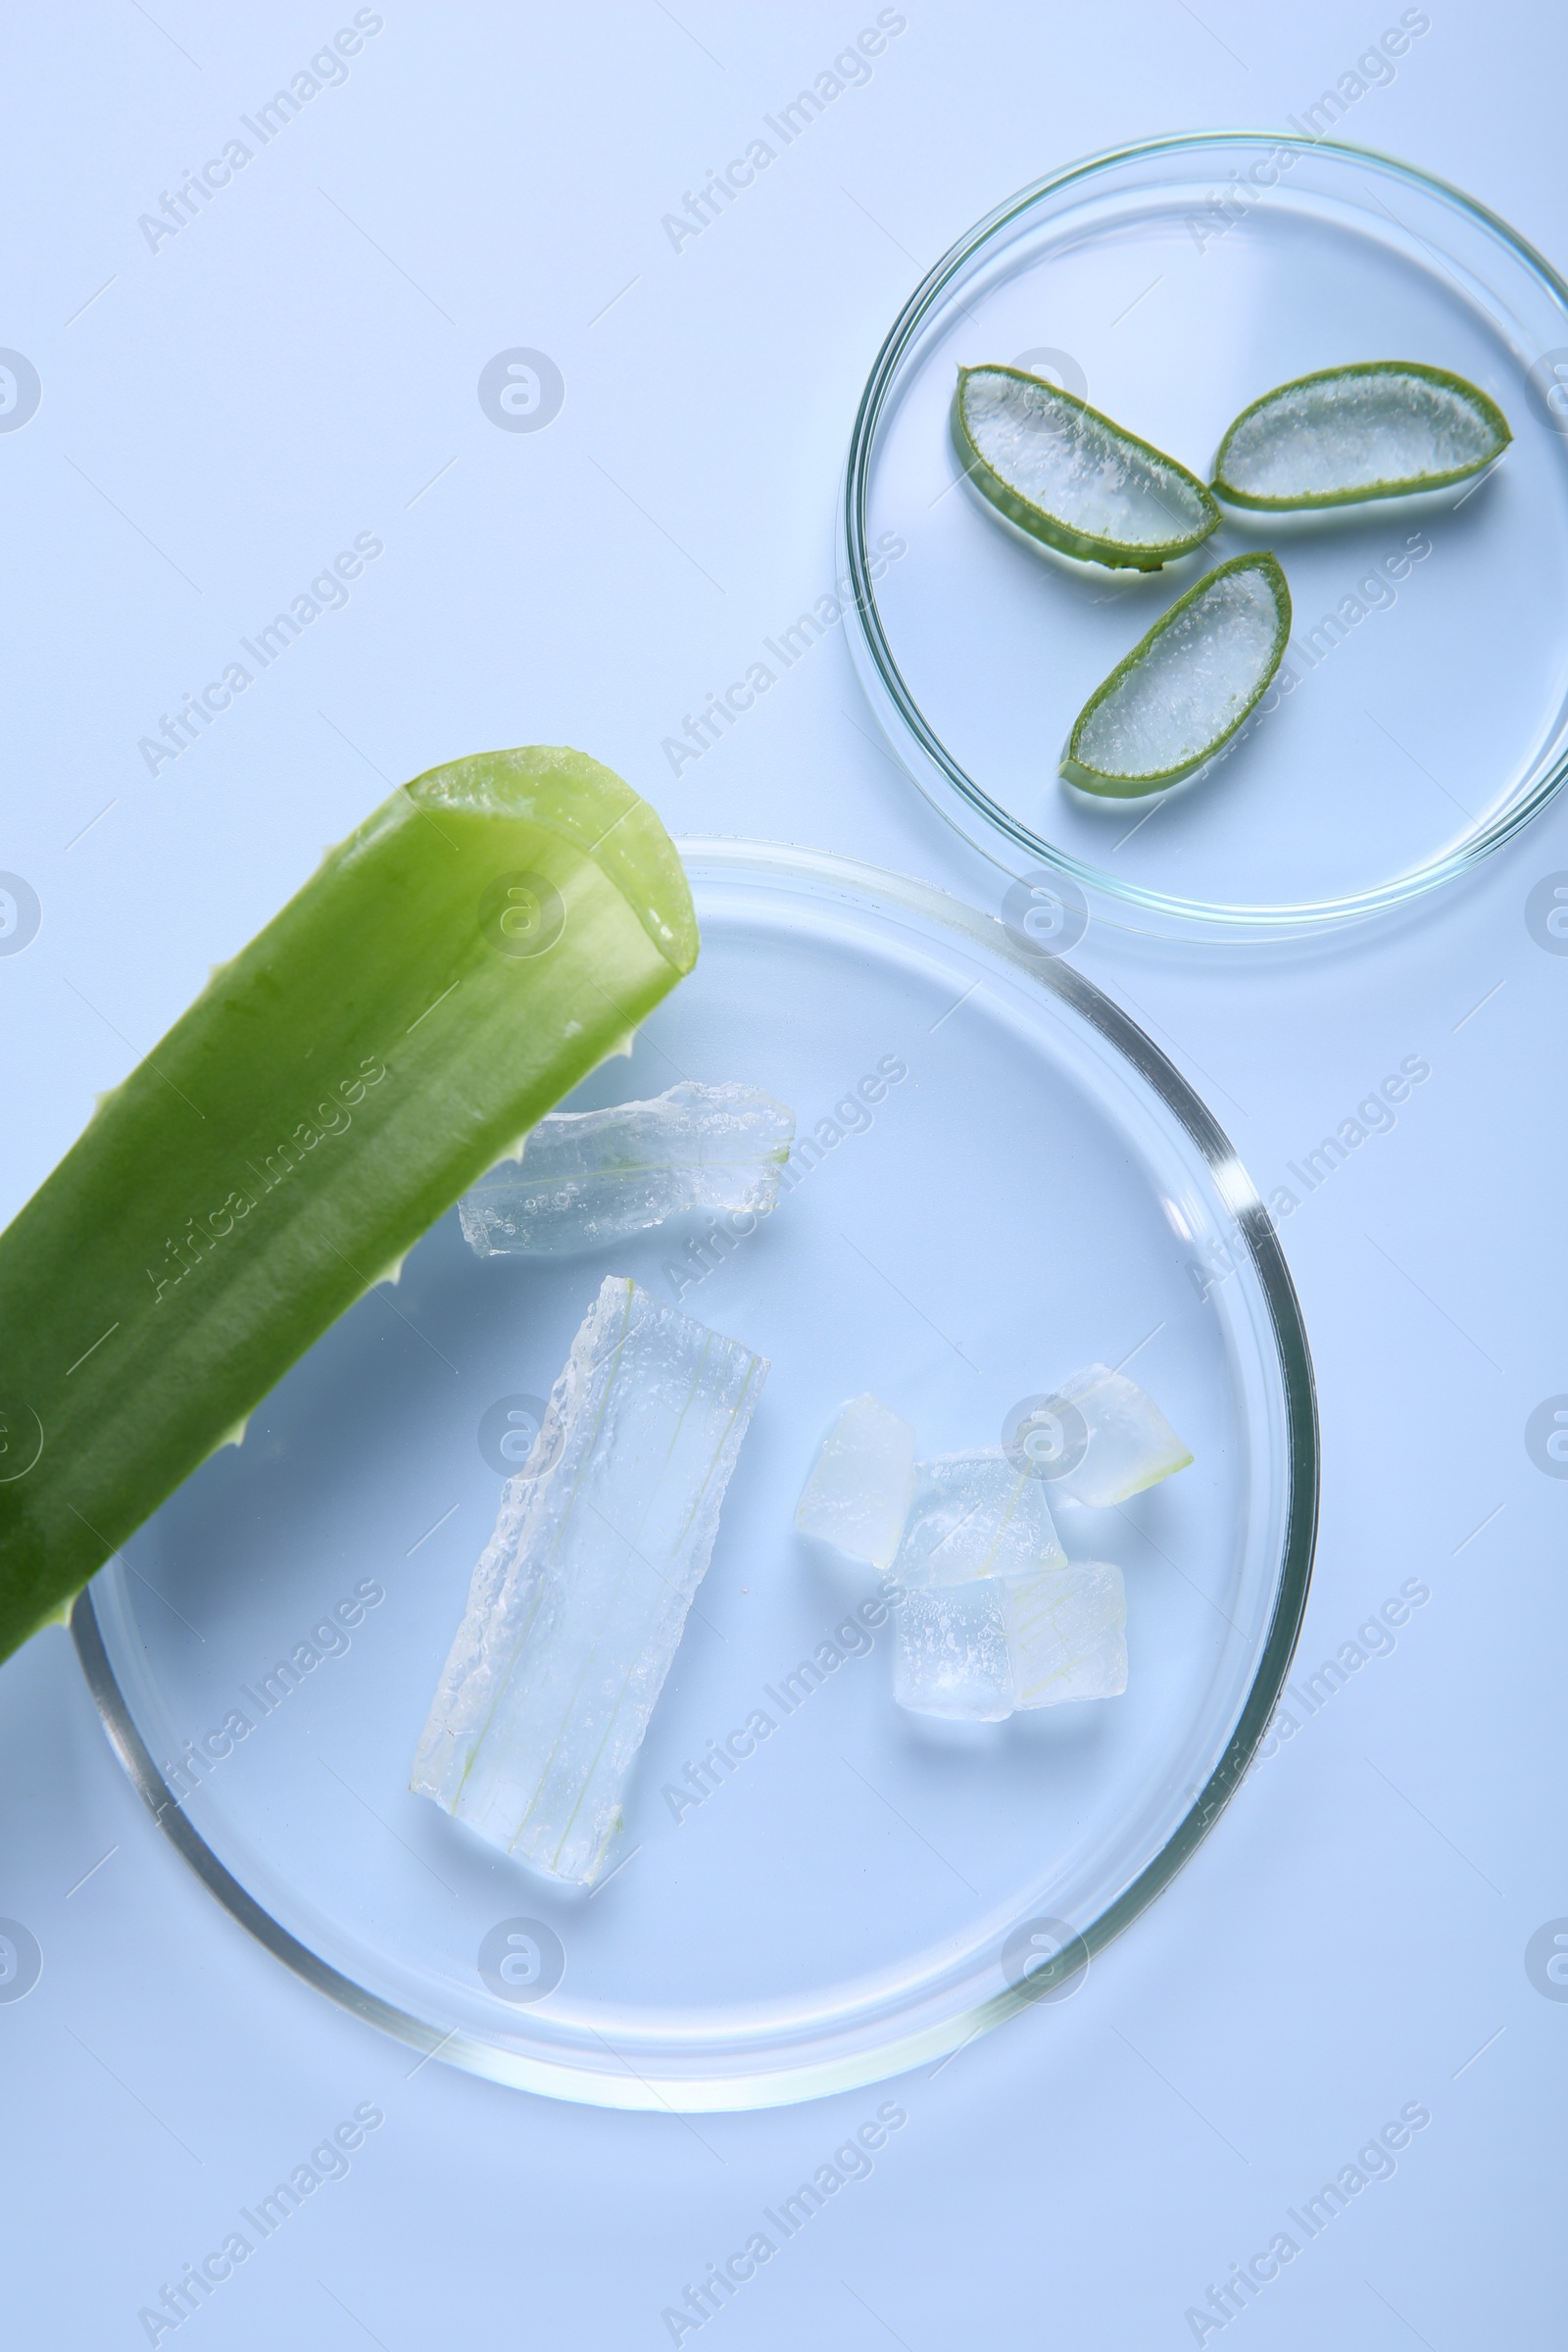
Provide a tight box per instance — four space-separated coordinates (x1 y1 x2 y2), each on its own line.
1213 360 1514 513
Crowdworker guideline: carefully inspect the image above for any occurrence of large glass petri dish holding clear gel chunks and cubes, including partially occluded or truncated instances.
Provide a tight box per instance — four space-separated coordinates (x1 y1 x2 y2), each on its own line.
73 842 1316 2110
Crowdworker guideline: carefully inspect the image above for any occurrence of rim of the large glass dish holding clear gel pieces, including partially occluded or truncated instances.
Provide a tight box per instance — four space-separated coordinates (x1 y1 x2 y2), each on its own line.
71 835 1319 2115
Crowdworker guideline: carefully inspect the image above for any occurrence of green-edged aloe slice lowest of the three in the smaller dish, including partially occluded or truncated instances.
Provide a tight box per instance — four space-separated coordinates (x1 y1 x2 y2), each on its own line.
1062 555 1291 800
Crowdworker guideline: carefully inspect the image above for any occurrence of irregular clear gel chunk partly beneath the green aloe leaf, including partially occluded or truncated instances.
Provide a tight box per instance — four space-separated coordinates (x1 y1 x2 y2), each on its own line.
459 1080 795 1258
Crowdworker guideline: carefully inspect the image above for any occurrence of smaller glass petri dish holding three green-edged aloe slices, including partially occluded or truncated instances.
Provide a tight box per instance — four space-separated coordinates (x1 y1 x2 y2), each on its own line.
839 131 1568 941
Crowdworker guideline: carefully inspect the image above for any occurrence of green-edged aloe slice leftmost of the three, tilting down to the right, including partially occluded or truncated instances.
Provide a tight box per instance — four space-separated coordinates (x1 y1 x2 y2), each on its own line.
953 367 1220 571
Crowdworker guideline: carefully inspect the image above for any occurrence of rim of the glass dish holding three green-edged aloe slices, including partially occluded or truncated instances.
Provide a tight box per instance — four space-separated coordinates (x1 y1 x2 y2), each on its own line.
837 127 1568 946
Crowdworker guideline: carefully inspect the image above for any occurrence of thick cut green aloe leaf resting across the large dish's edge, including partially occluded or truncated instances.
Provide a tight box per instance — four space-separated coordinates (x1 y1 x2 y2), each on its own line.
0 748 698 1656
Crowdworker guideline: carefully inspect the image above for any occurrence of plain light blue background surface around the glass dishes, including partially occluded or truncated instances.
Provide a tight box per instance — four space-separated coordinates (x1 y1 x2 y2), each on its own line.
0 0 1568 2352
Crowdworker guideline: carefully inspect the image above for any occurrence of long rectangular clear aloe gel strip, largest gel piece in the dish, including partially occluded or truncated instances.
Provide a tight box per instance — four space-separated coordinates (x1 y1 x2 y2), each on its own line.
409 1277 768 1886
